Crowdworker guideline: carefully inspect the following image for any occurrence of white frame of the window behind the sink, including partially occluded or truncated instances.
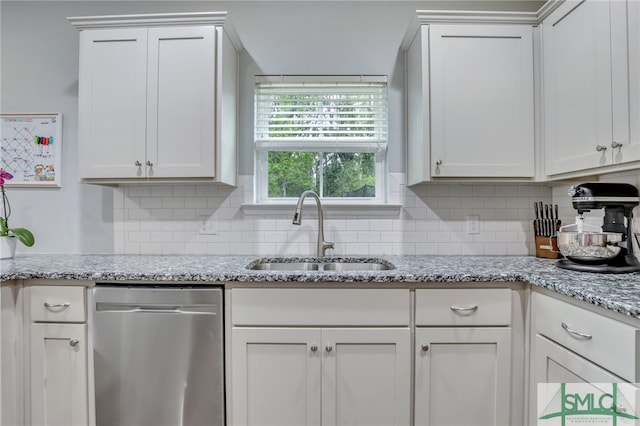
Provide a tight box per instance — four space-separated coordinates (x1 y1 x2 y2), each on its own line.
254 76 389 206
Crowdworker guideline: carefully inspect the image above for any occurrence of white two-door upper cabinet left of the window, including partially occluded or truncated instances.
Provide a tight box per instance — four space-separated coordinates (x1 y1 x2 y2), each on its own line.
69 13 239 185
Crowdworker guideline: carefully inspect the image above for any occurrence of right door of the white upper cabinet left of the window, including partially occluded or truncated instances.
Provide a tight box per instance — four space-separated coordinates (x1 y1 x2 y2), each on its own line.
146 26 216 177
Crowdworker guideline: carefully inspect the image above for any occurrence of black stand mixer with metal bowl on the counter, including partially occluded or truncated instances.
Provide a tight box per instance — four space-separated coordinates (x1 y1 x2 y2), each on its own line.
556 183 640 273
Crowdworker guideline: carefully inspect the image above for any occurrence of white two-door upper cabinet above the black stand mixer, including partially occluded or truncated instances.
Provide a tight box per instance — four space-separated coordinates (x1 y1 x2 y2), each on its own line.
542 0 640 176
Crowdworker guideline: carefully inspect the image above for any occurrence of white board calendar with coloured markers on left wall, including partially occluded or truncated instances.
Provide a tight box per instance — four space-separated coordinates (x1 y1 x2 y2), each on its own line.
0 113 62 187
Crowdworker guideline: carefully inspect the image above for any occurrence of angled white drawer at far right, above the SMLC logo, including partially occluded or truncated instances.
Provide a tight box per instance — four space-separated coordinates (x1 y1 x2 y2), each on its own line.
532 293 640 382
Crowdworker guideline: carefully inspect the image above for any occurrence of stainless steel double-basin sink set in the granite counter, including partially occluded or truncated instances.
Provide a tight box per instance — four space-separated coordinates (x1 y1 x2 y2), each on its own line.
247 258 395 272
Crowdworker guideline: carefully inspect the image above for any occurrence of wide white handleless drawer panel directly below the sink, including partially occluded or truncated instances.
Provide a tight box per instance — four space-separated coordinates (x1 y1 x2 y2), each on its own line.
231 288 410 326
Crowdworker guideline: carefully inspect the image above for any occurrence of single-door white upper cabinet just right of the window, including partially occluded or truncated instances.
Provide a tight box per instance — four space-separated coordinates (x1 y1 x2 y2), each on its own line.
405 15 535 185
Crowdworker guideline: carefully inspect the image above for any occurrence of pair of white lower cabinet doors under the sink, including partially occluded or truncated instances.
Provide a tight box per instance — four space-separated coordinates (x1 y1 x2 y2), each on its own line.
232 328 410 425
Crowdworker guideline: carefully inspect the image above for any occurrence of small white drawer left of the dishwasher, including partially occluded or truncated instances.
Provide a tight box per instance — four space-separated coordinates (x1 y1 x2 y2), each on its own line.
30 286 87 322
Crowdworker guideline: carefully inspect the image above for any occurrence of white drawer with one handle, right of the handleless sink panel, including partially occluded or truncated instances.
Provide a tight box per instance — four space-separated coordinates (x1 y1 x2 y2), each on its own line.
416 288 511 326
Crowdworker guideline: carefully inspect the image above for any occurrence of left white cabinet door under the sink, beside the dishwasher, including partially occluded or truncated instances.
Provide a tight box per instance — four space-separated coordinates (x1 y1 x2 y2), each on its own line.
231 328 322 426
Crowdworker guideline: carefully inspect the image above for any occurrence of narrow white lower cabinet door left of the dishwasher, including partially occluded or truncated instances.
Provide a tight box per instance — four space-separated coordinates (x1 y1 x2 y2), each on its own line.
30 324 88 426
